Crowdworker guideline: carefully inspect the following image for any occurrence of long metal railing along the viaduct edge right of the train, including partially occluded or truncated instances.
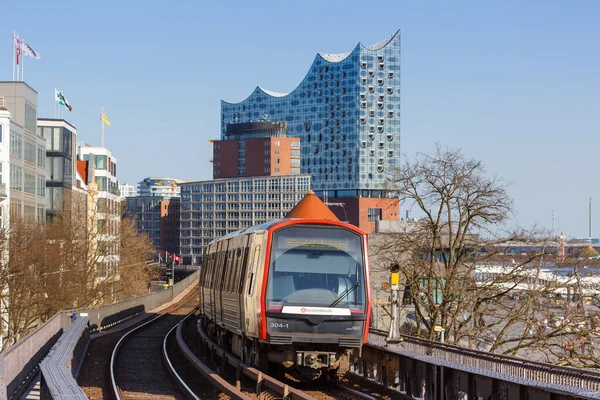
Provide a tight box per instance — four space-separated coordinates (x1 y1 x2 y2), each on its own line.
369 329 600 396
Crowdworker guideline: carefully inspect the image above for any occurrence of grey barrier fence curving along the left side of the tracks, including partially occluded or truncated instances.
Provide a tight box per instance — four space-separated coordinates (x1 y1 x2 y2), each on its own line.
0 270 199 400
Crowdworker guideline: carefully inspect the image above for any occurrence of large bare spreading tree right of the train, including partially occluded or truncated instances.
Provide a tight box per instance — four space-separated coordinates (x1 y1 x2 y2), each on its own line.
370 145 600 362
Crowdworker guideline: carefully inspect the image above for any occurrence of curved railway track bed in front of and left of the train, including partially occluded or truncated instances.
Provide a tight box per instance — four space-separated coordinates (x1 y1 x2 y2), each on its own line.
80 286 392 400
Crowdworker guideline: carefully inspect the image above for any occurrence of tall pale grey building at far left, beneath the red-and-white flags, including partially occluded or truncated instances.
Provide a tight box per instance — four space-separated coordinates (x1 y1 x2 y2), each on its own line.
0 81 46 222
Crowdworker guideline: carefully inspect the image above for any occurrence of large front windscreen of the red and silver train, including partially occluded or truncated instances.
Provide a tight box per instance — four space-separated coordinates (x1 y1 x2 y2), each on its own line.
266 226 365 311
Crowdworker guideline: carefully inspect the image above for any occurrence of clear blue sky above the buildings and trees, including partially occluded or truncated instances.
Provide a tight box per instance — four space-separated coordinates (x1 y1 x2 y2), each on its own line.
0 0 600 237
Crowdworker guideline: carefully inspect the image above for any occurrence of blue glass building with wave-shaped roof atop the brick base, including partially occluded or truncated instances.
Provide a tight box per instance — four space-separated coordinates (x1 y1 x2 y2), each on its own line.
221 31 400 198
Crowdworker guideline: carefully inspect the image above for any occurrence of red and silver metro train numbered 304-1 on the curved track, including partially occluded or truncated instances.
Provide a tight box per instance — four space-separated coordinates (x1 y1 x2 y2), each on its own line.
200 218 371 379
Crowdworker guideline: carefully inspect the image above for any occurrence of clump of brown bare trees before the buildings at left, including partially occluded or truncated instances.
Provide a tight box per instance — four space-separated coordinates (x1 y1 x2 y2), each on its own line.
0 191 157 346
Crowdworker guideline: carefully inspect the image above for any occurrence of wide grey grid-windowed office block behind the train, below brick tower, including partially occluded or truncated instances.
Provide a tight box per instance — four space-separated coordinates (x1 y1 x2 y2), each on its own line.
179 174 311 264
